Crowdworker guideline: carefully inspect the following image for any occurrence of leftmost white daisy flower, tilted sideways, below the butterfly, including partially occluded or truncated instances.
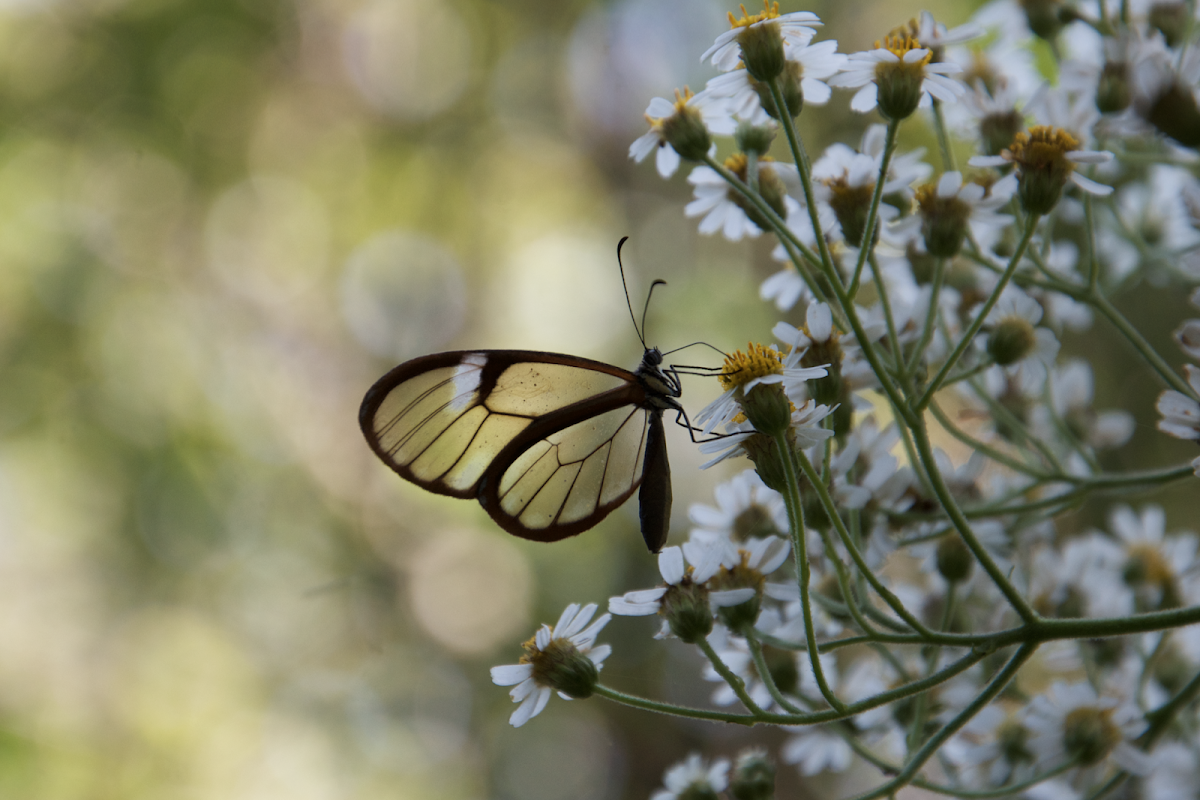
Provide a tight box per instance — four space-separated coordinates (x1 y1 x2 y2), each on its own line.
491 603 612 728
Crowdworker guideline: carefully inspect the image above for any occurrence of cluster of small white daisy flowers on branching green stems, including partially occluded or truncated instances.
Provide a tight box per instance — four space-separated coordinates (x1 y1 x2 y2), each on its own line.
493 6 1200 798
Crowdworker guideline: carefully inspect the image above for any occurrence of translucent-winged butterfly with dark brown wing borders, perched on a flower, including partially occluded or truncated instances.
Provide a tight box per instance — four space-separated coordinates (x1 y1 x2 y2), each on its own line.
359 239 690 553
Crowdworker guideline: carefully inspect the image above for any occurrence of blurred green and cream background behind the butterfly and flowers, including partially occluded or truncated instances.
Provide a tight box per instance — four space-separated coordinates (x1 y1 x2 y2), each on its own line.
0 0 1190 800
